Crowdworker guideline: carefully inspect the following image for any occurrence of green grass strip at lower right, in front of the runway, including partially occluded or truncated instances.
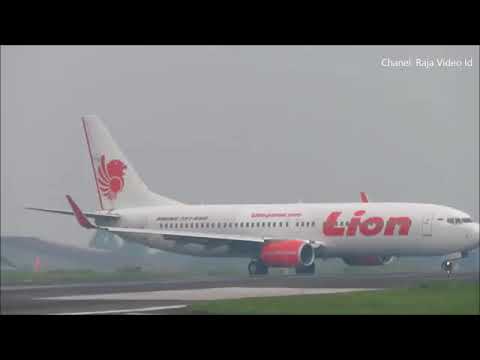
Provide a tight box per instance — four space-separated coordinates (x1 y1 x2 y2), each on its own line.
191 281 480 315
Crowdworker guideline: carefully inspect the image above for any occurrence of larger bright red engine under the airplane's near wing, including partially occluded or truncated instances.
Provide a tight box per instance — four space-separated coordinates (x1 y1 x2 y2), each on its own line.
260 240 315 267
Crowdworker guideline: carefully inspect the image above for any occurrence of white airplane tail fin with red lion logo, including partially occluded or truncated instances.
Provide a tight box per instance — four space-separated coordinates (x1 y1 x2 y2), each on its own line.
82 115 181 210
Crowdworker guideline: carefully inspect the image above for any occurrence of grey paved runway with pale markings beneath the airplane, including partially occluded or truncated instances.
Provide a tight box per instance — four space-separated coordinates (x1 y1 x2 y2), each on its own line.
1 272 479 315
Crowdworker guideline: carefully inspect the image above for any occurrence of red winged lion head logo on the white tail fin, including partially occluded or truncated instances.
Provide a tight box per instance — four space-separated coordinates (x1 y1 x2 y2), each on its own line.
98 155 127 200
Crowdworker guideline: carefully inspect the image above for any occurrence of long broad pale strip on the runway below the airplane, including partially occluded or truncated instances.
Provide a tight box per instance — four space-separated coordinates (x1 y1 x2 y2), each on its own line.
36 287 381 301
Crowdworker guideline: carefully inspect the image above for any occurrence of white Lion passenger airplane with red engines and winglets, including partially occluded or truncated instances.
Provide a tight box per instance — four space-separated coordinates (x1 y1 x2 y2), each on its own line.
26 115 479 276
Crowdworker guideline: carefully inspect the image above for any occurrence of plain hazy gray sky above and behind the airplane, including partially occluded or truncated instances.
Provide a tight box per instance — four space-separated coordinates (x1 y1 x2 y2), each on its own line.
1 46 479 246
